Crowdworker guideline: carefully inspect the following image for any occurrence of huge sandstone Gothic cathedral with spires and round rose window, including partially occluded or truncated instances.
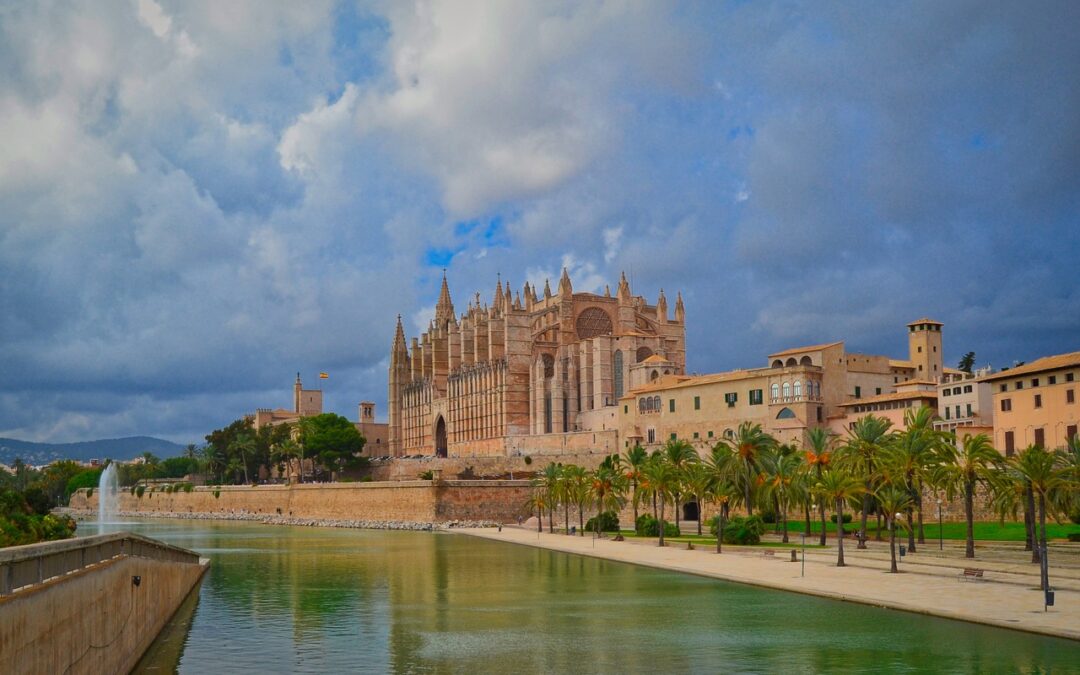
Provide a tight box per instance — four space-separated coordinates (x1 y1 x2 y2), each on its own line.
388 269 686 457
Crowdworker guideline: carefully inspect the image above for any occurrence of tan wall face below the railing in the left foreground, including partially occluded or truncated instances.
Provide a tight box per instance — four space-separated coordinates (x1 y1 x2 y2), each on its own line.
0 537 205 674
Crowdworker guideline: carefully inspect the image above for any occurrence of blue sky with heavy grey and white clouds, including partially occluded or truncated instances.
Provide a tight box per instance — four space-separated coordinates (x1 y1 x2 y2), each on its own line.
0 0 1080 443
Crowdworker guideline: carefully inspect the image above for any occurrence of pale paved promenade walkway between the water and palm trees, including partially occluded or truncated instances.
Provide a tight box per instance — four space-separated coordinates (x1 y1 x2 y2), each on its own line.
455 527 1080 640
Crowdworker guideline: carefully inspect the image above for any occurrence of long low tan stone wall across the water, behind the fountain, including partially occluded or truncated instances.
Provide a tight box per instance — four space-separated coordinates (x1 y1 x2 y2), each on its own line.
70 481 530 523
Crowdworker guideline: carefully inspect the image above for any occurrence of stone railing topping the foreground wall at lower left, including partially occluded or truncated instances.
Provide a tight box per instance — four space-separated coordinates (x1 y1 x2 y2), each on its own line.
0 532 199 595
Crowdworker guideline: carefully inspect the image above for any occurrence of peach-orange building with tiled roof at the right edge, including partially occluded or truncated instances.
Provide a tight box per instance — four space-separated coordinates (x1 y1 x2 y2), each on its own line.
985 352 1080 456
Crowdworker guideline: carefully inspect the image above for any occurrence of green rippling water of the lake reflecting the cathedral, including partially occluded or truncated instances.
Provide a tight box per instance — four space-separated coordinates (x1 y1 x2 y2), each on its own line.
97 521 1080 674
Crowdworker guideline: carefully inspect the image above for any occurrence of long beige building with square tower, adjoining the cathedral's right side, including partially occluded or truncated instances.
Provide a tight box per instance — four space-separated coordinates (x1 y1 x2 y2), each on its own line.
618 319 957 449
